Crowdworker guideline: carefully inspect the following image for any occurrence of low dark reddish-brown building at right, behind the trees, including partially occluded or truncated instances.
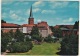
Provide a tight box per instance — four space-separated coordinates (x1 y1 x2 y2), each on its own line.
54 25 79 36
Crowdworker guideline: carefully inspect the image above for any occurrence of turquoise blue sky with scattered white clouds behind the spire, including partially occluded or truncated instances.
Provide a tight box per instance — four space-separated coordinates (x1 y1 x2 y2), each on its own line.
1 0 79 26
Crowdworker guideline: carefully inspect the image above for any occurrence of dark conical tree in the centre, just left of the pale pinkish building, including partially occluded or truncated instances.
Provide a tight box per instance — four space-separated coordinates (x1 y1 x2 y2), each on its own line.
31 26 42 42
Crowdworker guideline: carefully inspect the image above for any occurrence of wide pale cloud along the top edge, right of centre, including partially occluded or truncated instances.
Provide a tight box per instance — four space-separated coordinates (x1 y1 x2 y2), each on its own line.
50 1 69 8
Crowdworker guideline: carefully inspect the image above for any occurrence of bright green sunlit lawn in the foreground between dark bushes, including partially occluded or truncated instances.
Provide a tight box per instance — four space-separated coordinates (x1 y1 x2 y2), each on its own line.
8 43 60 55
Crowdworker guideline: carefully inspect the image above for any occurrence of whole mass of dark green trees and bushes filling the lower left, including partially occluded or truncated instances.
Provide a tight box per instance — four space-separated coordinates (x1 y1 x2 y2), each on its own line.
1 29 33 52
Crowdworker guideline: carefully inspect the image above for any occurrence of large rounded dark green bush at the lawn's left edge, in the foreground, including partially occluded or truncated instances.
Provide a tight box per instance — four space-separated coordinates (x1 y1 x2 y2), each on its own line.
10 41 33 52
